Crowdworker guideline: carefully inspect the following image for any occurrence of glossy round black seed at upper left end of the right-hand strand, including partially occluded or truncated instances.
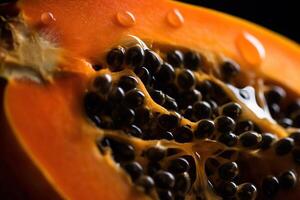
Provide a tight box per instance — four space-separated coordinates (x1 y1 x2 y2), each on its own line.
177 69 196 90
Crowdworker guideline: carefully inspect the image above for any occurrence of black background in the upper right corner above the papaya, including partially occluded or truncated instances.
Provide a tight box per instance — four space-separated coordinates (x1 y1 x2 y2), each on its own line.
181 0 300 43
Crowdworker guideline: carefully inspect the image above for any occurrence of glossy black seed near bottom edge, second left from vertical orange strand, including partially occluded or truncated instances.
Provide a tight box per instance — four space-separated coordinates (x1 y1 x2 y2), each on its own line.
154 170 175 189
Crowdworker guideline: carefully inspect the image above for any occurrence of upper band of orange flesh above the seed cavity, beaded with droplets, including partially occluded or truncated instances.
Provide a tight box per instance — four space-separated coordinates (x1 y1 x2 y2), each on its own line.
20 0 299 91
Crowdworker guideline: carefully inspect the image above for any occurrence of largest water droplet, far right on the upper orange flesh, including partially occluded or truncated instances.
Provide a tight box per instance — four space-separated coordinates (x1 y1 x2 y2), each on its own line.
236 33 266 65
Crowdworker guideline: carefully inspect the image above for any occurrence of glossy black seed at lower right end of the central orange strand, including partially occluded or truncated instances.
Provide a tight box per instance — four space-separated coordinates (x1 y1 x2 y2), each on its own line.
195 119 215 138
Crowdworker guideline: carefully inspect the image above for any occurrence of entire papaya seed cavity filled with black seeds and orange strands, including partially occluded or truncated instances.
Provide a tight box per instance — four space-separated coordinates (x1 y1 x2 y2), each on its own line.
83 37 300 200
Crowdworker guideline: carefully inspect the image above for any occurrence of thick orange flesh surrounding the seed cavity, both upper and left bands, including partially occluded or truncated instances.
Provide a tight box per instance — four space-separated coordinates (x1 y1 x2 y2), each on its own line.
1 0 300 200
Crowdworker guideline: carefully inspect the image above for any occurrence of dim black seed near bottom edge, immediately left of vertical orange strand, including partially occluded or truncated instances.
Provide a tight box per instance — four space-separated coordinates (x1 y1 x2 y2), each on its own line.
174 172 191 195
